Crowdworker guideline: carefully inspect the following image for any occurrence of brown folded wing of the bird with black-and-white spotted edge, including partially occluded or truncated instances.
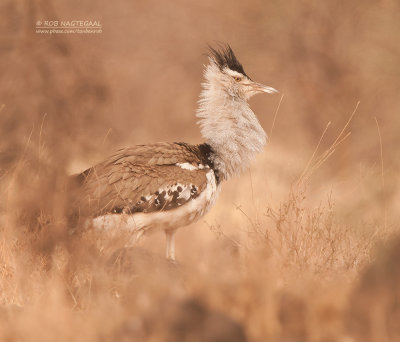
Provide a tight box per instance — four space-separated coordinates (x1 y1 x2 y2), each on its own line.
72 143 209 216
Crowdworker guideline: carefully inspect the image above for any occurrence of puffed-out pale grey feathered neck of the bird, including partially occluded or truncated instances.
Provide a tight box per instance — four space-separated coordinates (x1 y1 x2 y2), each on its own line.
196 83 267 179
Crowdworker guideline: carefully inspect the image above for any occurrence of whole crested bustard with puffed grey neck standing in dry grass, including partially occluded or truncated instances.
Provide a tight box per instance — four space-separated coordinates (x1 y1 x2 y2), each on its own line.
75 44 278 262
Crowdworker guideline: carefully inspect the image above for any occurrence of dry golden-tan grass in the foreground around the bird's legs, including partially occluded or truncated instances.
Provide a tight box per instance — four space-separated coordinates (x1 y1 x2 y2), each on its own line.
0 115 398 341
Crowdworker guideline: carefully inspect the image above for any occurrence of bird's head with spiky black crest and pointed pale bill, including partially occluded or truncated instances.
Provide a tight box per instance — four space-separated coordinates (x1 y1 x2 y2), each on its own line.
205 45 278 101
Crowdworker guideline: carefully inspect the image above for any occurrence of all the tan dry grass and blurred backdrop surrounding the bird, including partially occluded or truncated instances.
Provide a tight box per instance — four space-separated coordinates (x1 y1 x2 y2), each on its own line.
0 0 400 342
